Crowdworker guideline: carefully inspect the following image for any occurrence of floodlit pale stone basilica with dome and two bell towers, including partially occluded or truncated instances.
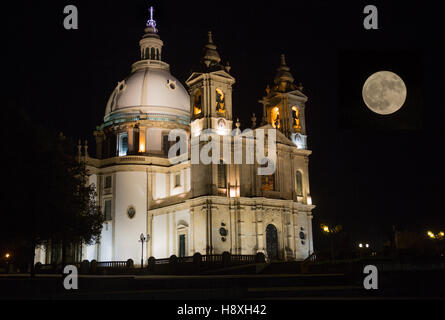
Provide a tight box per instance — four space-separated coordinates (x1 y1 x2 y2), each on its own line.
36 8 315 264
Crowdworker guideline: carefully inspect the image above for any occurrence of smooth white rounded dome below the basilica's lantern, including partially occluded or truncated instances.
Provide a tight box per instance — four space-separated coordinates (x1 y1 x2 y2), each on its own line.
105 68 190 117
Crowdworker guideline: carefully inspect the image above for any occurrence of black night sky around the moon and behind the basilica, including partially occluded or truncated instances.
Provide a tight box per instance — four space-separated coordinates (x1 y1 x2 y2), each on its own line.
3 0 445 248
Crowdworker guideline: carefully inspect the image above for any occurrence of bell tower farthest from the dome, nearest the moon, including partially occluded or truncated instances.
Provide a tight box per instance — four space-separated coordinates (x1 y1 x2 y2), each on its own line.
259 54 308 149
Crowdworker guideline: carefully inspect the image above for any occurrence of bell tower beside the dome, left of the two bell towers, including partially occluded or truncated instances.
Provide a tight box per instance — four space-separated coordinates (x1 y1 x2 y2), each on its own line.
186 31 235 137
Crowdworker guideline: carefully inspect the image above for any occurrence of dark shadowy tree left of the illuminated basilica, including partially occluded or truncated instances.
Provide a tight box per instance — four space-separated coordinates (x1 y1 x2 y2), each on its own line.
0 109 103 273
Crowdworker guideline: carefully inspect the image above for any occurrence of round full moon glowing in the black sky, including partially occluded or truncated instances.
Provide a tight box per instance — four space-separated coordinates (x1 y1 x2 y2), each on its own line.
362 71 406 115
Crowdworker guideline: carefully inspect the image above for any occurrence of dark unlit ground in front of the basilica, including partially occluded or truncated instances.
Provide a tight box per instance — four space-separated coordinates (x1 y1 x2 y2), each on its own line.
0 270 445 301
